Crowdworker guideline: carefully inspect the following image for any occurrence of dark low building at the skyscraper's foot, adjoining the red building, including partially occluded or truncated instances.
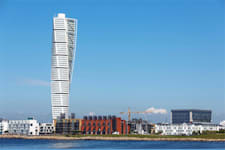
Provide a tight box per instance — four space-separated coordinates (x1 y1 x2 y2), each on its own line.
54 113 81 135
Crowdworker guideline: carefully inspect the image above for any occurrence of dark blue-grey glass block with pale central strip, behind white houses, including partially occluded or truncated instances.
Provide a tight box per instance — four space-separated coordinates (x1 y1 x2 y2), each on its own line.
171 109 212 124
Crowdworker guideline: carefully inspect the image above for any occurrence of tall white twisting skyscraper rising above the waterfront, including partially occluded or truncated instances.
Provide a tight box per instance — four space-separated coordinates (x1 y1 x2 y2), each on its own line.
51 14 77 119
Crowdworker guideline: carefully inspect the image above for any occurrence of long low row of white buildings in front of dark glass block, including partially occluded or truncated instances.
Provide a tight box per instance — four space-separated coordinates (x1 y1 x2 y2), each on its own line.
155 123 225 135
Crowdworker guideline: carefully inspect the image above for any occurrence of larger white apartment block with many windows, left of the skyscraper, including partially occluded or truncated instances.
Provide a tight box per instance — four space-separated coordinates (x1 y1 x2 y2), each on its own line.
8 118 39 135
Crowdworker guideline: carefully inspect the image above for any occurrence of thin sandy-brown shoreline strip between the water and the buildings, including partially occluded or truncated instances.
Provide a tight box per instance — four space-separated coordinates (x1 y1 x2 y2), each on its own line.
0 135 225 142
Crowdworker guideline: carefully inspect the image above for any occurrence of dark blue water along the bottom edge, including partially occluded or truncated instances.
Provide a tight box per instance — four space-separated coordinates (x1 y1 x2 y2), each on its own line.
0 139 225 149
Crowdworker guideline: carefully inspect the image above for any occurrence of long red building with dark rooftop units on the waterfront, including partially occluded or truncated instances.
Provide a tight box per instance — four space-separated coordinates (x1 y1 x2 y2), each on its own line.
81 116 129 134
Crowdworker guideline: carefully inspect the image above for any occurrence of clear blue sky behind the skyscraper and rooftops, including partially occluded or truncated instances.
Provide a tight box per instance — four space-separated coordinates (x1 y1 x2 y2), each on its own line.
0 0 225 122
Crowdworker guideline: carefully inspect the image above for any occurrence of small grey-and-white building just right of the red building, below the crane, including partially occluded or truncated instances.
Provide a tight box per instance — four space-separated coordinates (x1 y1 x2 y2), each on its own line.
129 119 153 134
